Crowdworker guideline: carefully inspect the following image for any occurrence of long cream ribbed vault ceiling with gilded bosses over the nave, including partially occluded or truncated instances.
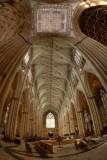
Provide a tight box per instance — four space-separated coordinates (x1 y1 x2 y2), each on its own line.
32 38 73 110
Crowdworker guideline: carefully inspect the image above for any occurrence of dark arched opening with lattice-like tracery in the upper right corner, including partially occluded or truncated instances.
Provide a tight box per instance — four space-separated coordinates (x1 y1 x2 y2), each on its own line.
79 6 107 45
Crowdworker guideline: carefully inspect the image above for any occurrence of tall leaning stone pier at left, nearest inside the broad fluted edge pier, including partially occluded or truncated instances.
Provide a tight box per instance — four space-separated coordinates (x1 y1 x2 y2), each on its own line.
6 72 23 139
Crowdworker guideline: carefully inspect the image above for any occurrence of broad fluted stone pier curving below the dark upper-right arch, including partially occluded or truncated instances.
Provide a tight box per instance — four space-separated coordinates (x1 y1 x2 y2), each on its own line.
77 37 107 91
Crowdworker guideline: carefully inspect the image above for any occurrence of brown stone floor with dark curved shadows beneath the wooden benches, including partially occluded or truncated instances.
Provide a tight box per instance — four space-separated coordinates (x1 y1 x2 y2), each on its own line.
0 138 107 160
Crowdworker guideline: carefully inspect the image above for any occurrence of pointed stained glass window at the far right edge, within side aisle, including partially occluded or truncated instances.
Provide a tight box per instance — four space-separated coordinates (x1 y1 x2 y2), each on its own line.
100 89 107 114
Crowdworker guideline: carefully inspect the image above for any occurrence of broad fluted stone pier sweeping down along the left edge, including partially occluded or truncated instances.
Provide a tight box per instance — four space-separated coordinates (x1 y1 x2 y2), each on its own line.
0 36 30 121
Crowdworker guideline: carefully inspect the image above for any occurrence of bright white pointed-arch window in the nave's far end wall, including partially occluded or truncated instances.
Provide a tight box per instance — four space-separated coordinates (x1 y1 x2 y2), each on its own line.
46 112 55 128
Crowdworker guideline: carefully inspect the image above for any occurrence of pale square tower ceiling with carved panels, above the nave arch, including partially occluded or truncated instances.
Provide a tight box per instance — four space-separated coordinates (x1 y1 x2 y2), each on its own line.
31 1 72 35
